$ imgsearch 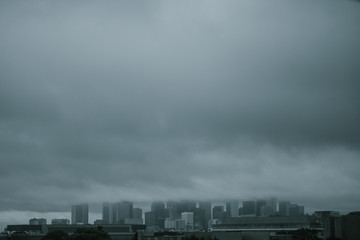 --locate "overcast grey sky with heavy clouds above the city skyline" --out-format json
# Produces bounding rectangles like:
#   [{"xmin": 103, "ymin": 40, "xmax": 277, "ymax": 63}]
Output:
[{"xmin": 0, "ymin": 0, "xmax": 360, "ymax": 224}]
